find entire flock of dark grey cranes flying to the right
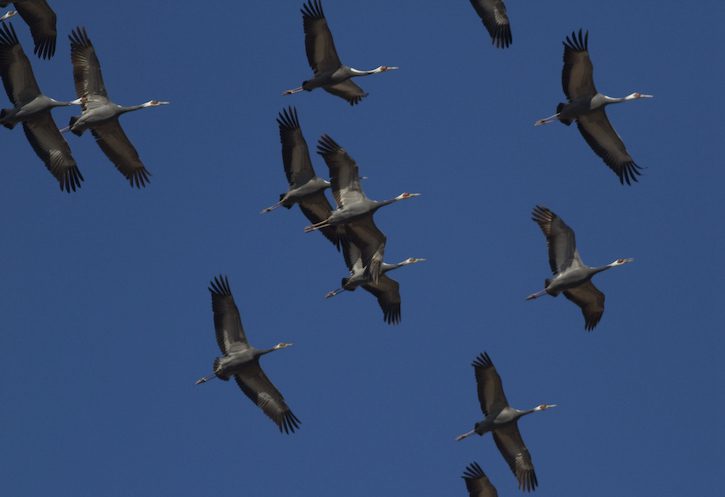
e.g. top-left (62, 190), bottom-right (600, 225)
top-left (0, 0), bottom-right (651, 497)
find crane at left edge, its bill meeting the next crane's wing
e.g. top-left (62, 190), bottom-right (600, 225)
top-left (0, 23), bottom-right (83, 193)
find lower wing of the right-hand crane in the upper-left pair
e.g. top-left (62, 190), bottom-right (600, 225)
top-left (91, 118), bottom-right (151, 188)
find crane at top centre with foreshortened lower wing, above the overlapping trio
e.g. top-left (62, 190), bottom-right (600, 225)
top-left (282, 0), bottom-right (398, 105)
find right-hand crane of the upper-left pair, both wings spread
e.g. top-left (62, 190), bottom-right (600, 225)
top-left (63, 27), bottom-right (169, 188)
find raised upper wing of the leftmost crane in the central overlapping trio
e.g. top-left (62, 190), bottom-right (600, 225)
top-left (277, 107), bottom-right (315, 188)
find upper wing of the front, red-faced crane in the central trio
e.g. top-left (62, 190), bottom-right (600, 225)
top-left (317, 135), bottom-right (366, 207)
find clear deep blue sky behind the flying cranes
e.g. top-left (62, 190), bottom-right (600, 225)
top-left (0, 0), bottom-right (725, 497)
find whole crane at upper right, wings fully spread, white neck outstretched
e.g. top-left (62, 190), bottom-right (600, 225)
top-left (534, 29), bottom-right (653, 185)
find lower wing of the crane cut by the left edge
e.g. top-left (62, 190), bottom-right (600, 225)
top-left (23, 111), bottom-right (83, 193)
